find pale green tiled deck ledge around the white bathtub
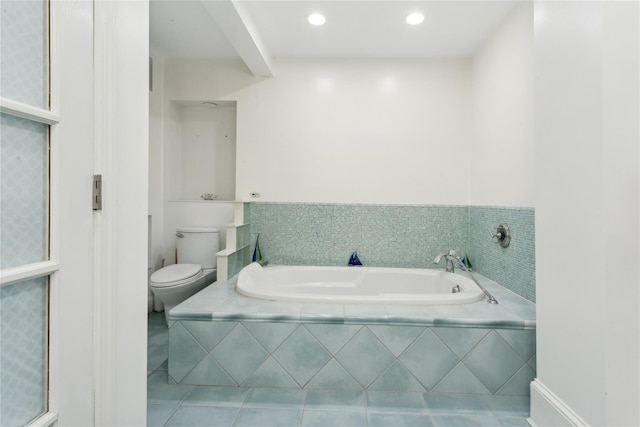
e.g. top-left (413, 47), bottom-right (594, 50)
top-left (169, 272), bottom-right (536, 329)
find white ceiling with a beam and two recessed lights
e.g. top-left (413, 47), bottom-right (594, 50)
top-left (150, 0), bottom-right (517, 75)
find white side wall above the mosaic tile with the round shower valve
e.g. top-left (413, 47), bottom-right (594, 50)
top-left (469, 1), bottom-right (535, 207)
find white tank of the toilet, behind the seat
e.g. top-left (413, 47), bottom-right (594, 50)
top-left (176, 227), bottom-right (220, 269)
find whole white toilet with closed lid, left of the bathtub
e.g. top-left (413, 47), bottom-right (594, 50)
top-left (149, 227), bottom-right (220, 322)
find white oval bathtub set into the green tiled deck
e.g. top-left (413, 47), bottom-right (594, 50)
top-left (237, 263), bottom-right (484, 305)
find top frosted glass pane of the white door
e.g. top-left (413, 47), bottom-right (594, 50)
top-left (0, 0), bottom-right (49, 108)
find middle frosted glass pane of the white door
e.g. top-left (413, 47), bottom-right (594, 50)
top-left (0, 114), bottom-right (49, 269)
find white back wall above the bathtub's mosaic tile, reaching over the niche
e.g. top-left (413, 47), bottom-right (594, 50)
top-left (166, 60), bottom-right (470, 204)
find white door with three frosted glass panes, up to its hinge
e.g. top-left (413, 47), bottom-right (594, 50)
top-left (0, 1), bottom-right (94, 426)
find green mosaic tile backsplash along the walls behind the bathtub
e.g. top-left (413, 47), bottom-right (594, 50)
top-left (245, 203), bottom-right (535, 302)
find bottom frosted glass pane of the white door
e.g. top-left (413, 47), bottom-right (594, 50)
top-left (0, 277), bottom-right (48, 427)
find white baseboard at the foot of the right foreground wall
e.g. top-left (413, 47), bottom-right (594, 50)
top-left (527, 378), bottom-right (588, 427)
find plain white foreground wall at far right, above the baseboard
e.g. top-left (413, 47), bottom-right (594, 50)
top-left (531, 1), bottom-right (640, 426)
